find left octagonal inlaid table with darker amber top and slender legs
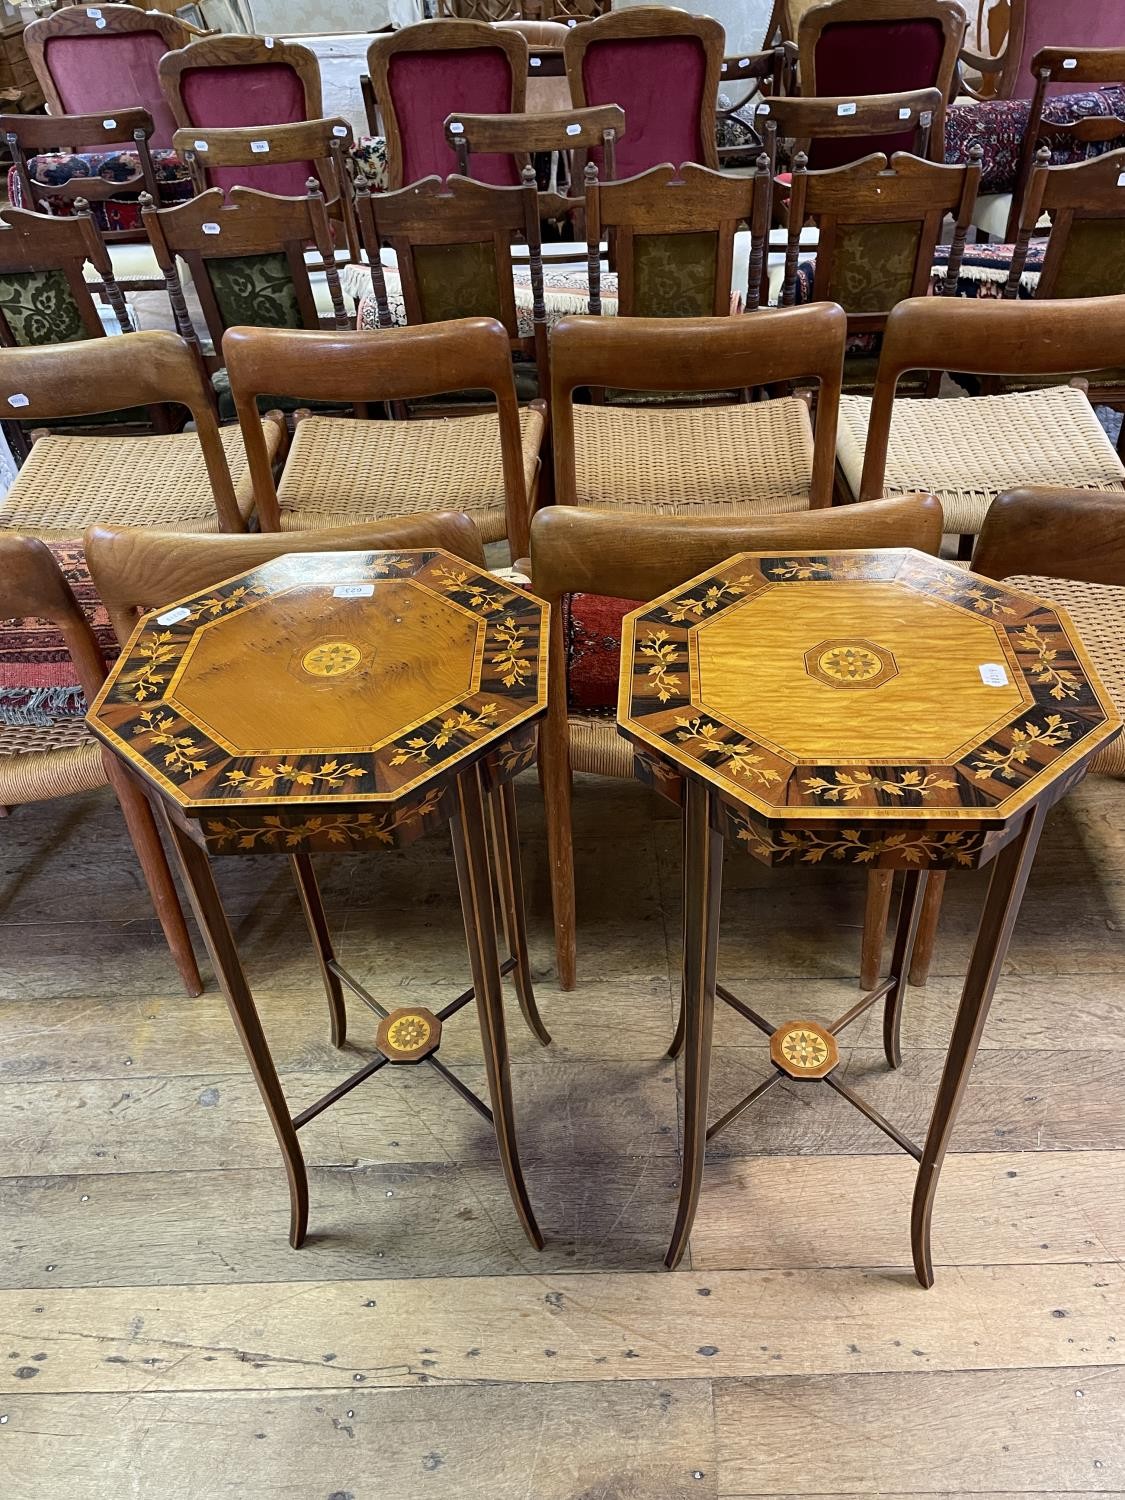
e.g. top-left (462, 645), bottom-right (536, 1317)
top-left (90, 551), bottom-right (551, 1247)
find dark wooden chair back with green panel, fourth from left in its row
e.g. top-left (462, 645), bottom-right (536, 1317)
top-left (585, 156), bottom-right (773, 318)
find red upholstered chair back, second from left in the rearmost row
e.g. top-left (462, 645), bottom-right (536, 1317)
top-left (161, 35), bottom-right (324, 198)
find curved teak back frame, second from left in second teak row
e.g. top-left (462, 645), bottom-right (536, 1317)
top-left (225, 318), bottom-right (543, 557)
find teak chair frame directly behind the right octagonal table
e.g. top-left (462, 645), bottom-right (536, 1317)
top-left (531, 498), bottom-right (942, 990)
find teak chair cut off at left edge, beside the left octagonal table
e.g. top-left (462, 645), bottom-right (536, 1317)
top-left (0, 534), bottom-right (203, 995)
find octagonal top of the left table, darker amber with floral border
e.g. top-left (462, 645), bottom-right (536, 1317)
top-left (89, 551), bottom-right (549, 828)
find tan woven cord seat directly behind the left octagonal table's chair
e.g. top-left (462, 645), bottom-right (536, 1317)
top-left (278, 407), bottom-right (545, 542)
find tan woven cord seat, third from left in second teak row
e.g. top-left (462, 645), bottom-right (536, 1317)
top-left (575, 396), bottom-right (813, 519)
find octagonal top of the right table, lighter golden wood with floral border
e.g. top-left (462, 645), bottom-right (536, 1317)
top-left (618, 549), bottom-right (1121, 846)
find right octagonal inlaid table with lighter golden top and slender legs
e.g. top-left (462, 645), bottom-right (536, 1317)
top-left (618, 551), bottom-right (1121, 1286)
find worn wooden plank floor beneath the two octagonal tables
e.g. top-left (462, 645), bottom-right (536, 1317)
top-left (0, 779), bottom-right (1125, 1500)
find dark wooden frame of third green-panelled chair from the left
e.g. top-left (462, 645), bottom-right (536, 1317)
top-left (356, 167), bottom-right (549, 395)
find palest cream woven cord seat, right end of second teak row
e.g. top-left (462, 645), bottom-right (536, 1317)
top-left (836, 386), bottom-right (1125, 536)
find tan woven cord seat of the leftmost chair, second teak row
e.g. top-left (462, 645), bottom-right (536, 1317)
top-left (0, 422), bottom-right (281, 539)
